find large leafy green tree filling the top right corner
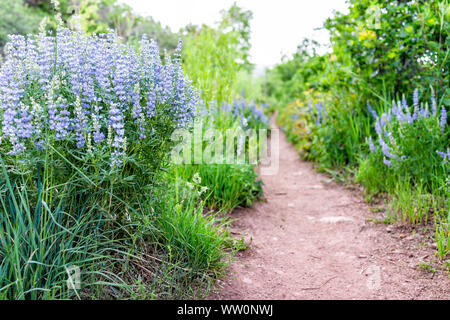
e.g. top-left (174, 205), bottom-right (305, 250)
top-left (325, 0), bottom-right (450, 105)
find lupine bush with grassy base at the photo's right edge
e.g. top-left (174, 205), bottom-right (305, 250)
top-left (356, 91), bottom-right (450, 228)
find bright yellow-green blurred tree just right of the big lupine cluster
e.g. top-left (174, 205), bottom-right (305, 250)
top-left (183, 4), bottom-right (253, 106)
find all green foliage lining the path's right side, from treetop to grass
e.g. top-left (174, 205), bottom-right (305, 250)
top-left (266, 0), bottom-right (450, 256)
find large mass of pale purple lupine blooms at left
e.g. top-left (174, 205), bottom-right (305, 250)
top-left (0, 27), bottom-right (198, 166)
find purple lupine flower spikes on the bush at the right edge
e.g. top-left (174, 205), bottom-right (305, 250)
top-left (367, 89), bottom-right (450, 167)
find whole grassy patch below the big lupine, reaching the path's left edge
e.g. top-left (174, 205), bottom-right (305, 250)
top-left (0, 146), bottom-right (239, 299)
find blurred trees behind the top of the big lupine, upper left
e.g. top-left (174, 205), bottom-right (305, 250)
top-left (0, 0), bottom-right (180, 51)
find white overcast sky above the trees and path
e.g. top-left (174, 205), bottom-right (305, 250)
top-left (121, 0), bottom-right (348, 66)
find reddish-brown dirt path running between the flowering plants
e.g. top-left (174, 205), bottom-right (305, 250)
top-left (208, 122), bottom-right (450, 299)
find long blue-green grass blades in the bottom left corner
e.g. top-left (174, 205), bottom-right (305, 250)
top-left (0, 161), bottom-right (134, 299)
